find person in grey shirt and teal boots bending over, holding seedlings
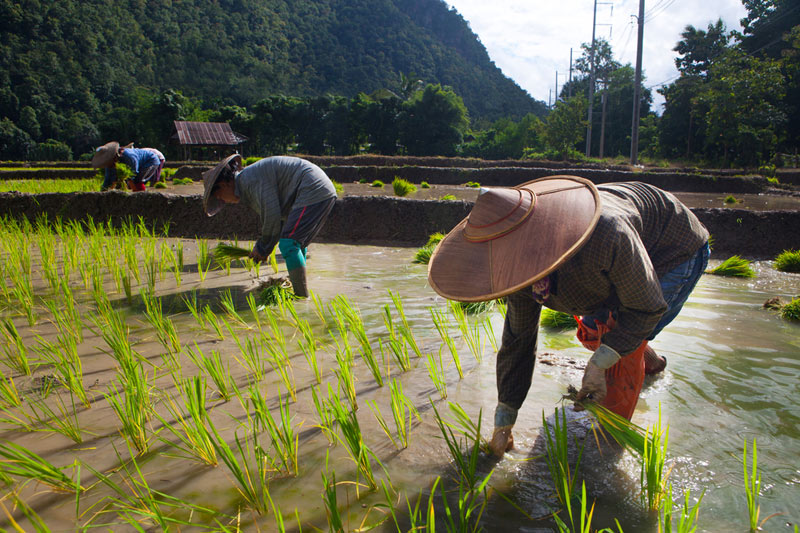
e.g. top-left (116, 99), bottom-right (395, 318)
top-left (203, 154), bottom-right (336, 297)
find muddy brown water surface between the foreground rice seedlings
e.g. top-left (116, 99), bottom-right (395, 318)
top-left (1, 241), bottom-right (800, 531)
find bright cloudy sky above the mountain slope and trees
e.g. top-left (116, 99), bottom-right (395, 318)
top-left (445, 0), bottom-right (746, 113)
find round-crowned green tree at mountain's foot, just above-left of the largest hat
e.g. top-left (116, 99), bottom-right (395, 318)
top-left (400, 84), bottom-right (469, 156)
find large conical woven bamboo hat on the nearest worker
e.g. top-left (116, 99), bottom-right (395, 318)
top-left (428, 176), bottom-right (600, 302)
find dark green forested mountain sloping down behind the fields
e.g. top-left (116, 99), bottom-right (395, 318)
top-left (0, 0), bottom-right (545, 136)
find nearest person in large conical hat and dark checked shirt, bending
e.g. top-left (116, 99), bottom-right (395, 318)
top-left (428, 176), bottom-right (709, 456)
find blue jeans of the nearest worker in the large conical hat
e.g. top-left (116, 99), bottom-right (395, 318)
top-left (581, 243), bottom-right (711, 341)
